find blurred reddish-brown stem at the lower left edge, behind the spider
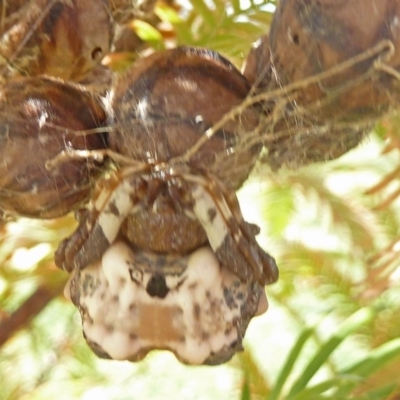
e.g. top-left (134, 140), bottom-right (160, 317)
top-left (0, 285), bottom-right (62, 347)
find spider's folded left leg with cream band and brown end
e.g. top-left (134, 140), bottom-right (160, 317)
top-left (55, 177), bottom-right (145, 271)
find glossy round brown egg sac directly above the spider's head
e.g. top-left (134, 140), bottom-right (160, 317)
top-left (110, 47), bottom-right (260, 189)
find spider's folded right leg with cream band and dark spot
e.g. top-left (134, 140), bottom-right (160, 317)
top-left (183, 174), bottom-right (279, 285)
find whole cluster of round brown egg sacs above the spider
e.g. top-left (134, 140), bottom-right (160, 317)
top-left (0, 0), bottom-right (400, 218)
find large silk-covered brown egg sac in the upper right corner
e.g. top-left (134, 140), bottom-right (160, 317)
top-left (245, 0), bottom-right (400, 168)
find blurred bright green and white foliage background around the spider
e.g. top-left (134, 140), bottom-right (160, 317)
top-left (0, 0), bottom-right (400, 400)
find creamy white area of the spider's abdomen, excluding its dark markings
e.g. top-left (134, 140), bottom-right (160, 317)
top-left (66, 242), bottom-right (263, 364)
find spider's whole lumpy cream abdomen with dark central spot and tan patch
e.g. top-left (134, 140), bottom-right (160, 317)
top-left (66, 242), bottom-right (268, 365)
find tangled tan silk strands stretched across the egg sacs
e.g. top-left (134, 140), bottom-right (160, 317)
top-left (1, 0), bottom-right (399, 366)
